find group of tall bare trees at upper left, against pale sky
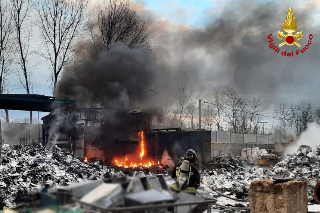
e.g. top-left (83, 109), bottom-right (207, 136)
top-left (0, 0), bottom-right (150, 123)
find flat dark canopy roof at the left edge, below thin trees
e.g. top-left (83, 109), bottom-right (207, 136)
top-left (0, 94), bottom-right (76, 112)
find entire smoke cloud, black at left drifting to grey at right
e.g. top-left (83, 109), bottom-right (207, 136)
top-left (58, 1), bottom-right (320, 118)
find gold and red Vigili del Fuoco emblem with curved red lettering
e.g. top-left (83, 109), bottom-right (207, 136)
top-left (268, 7), bottom-right (313, 57)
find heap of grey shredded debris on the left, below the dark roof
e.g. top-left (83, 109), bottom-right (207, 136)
top-left (0, 144), bottom-right (116, 208)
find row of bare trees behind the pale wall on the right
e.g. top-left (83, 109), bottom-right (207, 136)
top-left (166, 84), bottom-right (320, 135)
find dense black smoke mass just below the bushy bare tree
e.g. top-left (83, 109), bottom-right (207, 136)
top-left (57, 44), bottom-right (159, 109)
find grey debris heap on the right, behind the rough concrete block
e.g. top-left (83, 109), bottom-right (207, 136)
top-left (199, 145), bottom-right (320, 212)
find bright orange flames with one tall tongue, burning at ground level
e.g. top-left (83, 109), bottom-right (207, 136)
top-left (113, 131), bottom-right (155, 168)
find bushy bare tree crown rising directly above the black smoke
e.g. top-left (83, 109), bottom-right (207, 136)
top-left (98, 0), bottom-right (150, 50)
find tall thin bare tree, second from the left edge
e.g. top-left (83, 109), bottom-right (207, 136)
top-left (11, 0), bottom-right (32, 123)
